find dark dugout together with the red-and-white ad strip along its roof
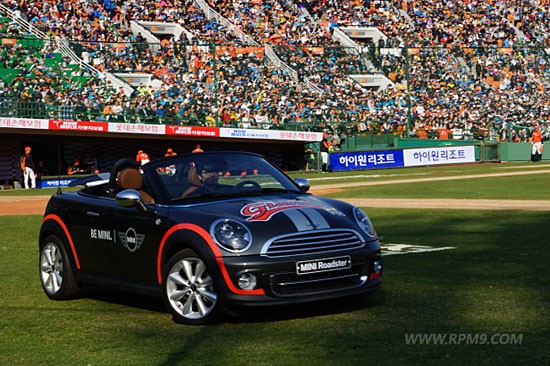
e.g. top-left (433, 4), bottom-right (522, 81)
top-left (0, 118), bottom-right (322, 186)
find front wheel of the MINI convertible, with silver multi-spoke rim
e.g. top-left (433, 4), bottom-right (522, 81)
top-left (162, 249), bottom-right (224, 325)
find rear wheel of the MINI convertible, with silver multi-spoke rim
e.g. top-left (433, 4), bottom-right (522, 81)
top-left (39, 235), bottom-right (80, 300)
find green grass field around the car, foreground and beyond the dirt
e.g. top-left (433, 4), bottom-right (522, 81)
top-left (0, 165), bottom-right (550, 366)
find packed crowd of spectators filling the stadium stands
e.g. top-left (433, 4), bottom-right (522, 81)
top-left (0, 0), bottom-right (550, 140)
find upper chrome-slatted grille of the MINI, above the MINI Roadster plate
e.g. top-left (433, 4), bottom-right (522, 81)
top-left (261, 230), bottom-right (364, 258)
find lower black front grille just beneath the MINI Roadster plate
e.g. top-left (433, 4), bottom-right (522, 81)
top-left (270, 265), bottom-right (367, 297)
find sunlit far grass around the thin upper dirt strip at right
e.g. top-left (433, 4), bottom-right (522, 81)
top-left (290, 163), bottom-right (550, 200)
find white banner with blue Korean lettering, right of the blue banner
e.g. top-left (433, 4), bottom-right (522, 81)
top-left (403, 145), bottom-right (476, 166)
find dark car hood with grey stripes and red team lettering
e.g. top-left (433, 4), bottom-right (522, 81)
top-left (172, 194), bottom-right (367, 250)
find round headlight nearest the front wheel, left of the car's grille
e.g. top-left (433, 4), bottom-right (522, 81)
top-left (210, 219), bottom-right (252, 253)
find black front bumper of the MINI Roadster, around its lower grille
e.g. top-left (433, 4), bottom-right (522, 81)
top-left (218, 249), bottom-right (382, 306)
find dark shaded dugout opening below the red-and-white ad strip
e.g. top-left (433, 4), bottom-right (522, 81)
top-left (0, 129), bottom-right (312, 186)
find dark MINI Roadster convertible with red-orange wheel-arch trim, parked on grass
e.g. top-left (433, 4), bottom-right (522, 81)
top-left (39, 151), bottom-right (382, 325)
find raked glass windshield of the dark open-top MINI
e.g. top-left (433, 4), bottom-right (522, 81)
top-left (144, 152), bottom-right (301, 202)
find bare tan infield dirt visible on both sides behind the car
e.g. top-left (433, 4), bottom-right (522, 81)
top-left (0, 169), bottom-right (550, 216)
